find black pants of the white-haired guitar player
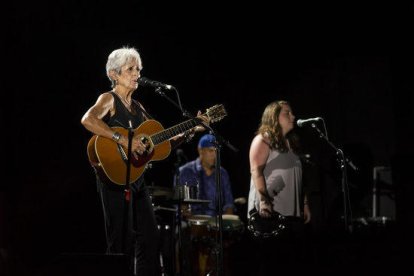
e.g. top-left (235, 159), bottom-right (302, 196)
top-left (98, 180), bottom-right (160, 276)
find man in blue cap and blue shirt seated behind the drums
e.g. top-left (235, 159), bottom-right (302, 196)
top-left (175, 134), bottom-right (234, 217)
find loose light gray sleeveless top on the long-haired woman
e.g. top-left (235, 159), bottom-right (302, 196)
top-left (247, 150), bottom-right (302, 217)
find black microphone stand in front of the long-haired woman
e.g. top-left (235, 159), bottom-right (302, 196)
top-left (311, 123), bottom-right (355, 233)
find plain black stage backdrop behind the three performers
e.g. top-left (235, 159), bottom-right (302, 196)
top-left (0, 0), bottom-right (414, 275)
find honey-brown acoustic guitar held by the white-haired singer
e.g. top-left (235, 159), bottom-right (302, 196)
top-left (87, 105), bottom-right (227, 185)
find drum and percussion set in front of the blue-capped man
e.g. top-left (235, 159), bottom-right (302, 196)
top-left (149, 185), bottom-right (245, 275)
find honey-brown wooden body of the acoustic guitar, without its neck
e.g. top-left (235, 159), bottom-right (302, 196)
top-left (88, 120), bottom-right (171, 185)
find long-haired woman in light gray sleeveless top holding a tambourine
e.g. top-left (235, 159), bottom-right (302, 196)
top-left (248, 101), bottom-right (311, 275)
